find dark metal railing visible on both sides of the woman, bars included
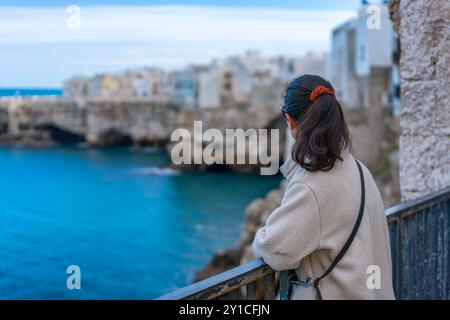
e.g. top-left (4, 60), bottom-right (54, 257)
top-left (158, 187), bottom-right (450, 300)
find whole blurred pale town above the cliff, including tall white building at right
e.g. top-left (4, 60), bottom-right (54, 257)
top-left (63, 4), bottom-right (400, 115)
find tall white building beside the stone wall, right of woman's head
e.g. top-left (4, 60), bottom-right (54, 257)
top-left (330, 4), bottom-right (395, 108)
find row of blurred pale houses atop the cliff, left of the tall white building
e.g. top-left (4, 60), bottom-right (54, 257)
top-left (64, 51), bottom-right (327, 110)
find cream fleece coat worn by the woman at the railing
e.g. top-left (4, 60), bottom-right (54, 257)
top-left (253, 152), bottom-right (394, 300)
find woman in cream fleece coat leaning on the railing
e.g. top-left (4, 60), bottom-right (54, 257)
top-left (253, 75), bottom-right (394, 299)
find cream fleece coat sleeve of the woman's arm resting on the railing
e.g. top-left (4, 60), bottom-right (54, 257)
top-left (252, 183), bottom-right (320, 271)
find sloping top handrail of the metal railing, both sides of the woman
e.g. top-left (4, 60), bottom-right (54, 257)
top-left (157, 186), bottom-right (450, 300)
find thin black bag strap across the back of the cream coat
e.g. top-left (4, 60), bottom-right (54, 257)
top-left (313, 159), bottom-right (366, 300)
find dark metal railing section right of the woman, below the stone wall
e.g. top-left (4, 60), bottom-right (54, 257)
top-left (386, 187), bottom-right (450, 300)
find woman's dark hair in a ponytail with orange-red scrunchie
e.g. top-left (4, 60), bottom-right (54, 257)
top-left (283, 75), bottom-right (351, 172)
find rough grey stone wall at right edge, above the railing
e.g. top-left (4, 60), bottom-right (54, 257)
top-left (390, 0), bottom-right (450, 200)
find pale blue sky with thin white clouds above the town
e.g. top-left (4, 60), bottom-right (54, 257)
top-left (0, 0), bottom-right (360, 88)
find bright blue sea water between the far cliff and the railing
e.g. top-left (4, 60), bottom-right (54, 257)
top-left (0, 148), bottom-right (280, 299)
